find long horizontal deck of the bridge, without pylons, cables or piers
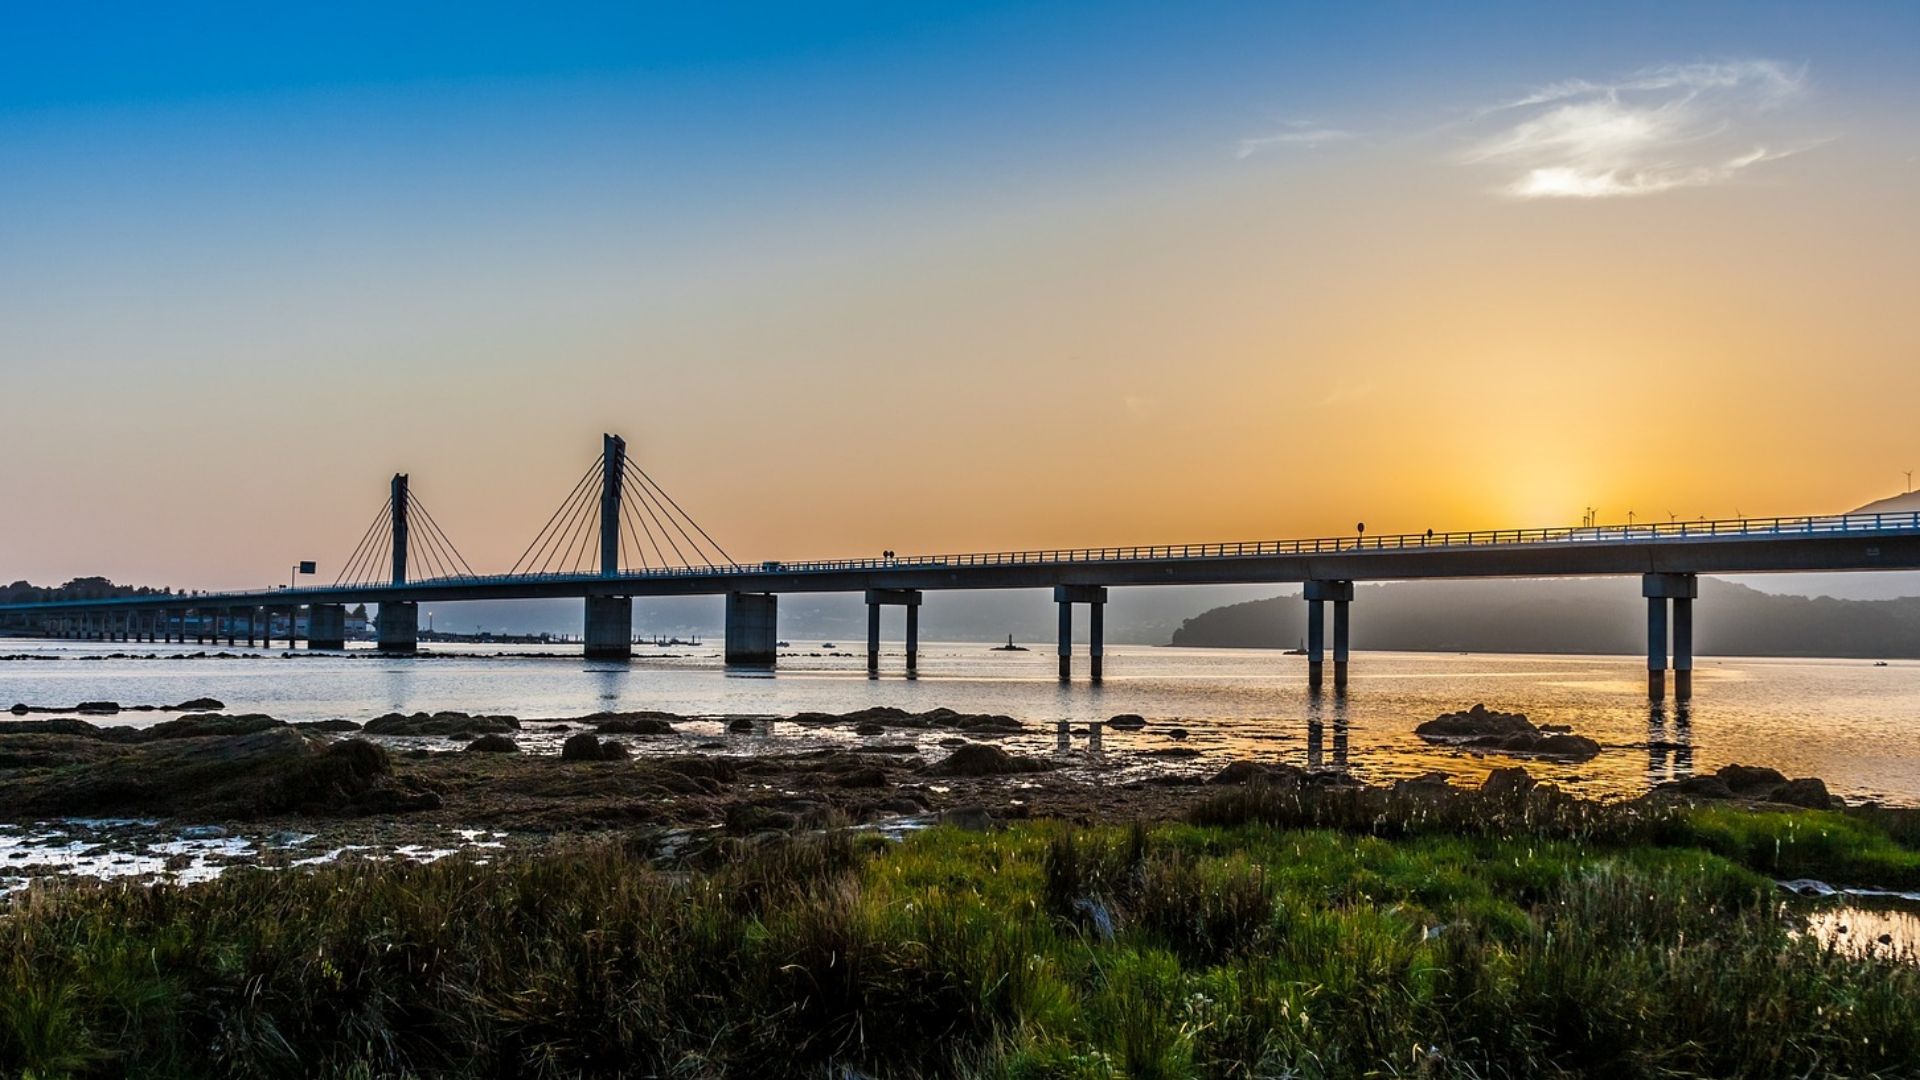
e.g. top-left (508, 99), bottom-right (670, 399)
top-left (0, 513), bottom-right (1920, 613)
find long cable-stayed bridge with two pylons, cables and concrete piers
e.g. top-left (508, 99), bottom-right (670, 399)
top-left (0, 434), bottom-right (1920, 701)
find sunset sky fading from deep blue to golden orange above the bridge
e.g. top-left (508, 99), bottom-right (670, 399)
top-left (0, 2), bottom-right (1920, 588)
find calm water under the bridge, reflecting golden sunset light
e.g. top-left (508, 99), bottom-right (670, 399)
top-left (0, 640), bottom-right (1920, 805)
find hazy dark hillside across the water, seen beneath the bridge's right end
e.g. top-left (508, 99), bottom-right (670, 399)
top-left (1171, 577), bottom-right (1920, 659)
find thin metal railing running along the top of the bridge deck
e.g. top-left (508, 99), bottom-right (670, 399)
top-left (15, 511), bottom-right (1920, 605)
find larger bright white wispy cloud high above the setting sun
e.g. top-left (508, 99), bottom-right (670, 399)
top-left (1463, 60), bottom-right (1814, 198)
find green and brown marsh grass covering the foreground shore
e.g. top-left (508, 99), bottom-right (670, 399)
top-left (0, 796), bottom-right (1920, 1080)
